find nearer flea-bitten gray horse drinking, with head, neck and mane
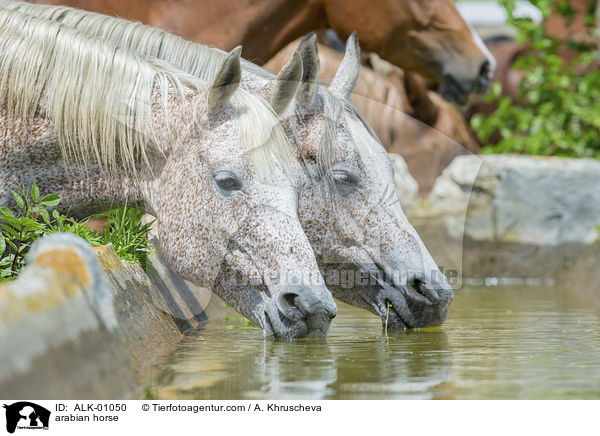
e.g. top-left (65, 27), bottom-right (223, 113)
top-left (0, 9), bottom-right (336, 338)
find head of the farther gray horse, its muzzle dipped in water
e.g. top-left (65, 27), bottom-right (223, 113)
top-left (284, 34), bottom-right (453, 328)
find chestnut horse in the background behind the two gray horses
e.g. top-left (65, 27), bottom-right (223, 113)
top-left (29, 0), bottom-right (496, 104)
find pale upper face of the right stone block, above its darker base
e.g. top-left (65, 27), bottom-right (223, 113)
top-left (429, 155), bottom-right (600, 247)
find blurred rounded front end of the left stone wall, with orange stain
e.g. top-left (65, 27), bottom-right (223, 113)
top-left (0, 234), bottom-right (136, 399)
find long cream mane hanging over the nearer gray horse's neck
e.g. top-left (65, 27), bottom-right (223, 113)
top-left (0, 6), bottom-right (202, 173)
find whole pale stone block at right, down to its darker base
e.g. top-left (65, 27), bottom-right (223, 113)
top-left (410, 155), bottom-right (600, 278)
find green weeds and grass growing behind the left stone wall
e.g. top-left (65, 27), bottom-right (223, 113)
top-left (0, 183), bottom-right (152, 280)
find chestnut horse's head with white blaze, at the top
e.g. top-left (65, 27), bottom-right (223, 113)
top-left (326, 0), bottom-right (496, 104)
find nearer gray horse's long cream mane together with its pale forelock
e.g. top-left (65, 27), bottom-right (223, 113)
top-left (0, 5), bottom-right (294, 173)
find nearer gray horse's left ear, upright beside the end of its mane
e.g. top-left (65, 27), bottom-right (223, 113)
top-left (208, 46), bottom-right (242, 114)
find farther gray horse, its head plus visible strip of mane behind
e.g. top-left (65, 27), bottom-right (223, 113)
top-left (3, 0), bottom-right (453, 328)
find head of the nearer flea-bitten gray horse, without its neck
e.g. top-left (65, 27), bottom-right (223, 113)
top-left (152, 49), bottom-right (336, 338)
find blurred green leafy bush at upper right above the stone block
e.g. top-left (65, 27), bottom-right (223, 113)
top-left (471, 0), bottom-right (600, 158)
